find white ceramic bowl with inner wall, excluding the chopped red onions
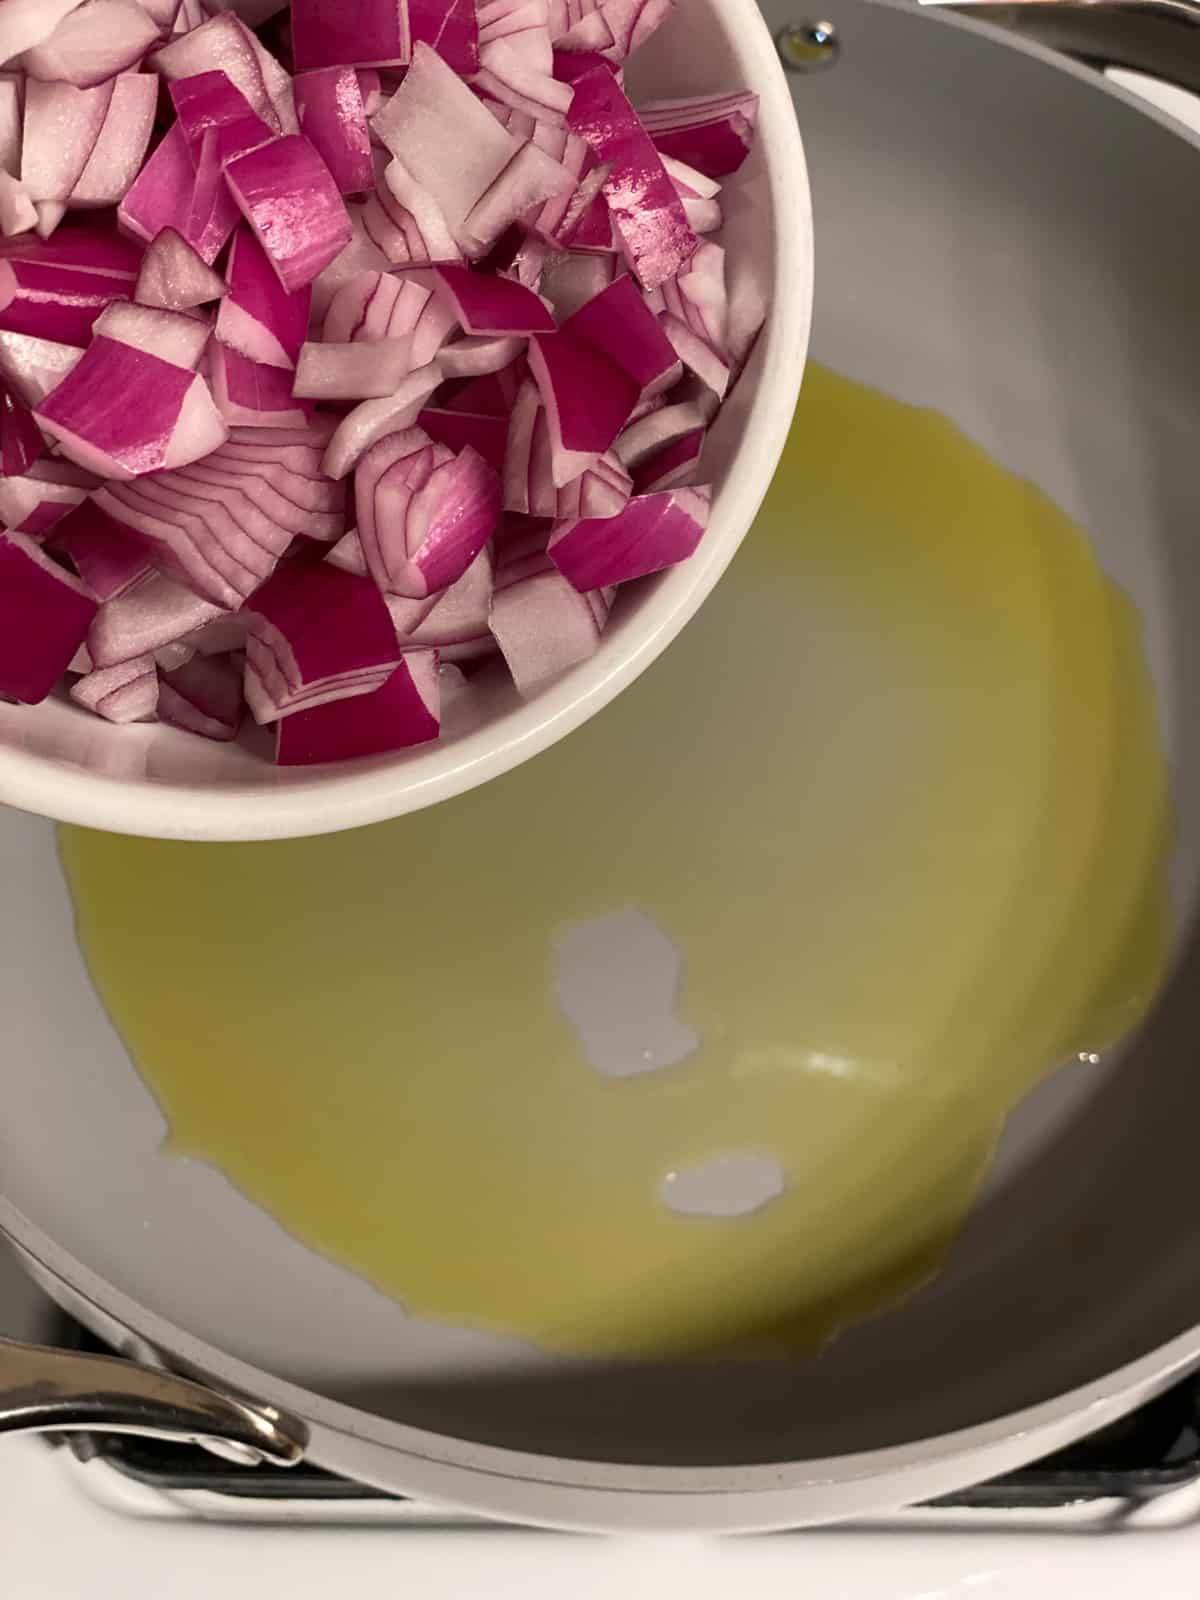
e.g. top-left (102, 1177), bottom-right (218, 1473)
top-left (0, 0), bottom-right (813, 838)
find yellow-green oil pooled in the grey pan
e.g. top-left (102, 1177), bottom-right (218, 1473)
top-left (61, 370), bottom-right (1171, 1355)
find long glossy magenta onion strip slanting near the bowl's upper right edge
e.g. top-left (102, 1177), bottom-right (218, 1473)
top-left (568, 67), bottom-right (698, 288)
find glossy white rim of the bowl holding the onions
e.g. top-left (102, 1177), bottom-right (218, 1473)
top-left (0, 0), bottom-right (813, 840)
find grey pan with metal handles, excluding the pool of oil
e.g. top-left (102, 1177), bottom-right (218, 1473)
top-left (0, 0), bottom-right (1200, 1531)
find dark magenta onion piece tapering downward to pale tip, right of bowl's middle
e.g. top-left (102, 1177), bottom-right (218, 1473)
top-left (528, 320), bottom-right (640, 488)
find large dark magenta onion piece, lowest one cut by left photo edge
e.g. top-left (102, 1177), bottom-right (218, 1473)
top-left (0, 533), bottom-right (96, 706)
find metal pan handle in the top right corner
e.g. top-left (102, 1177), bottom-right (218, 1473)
top-left (920, 0), bottom-right (1200, 94)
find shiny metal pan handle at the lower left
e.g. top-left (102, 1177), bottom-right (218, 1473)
top-left (0, 1339), bottom-right (307, 1467)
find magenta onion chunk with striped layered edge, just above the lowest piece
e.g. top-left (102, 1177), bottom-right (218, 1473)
top-left (246, 560), bottom-right (400, 722)
